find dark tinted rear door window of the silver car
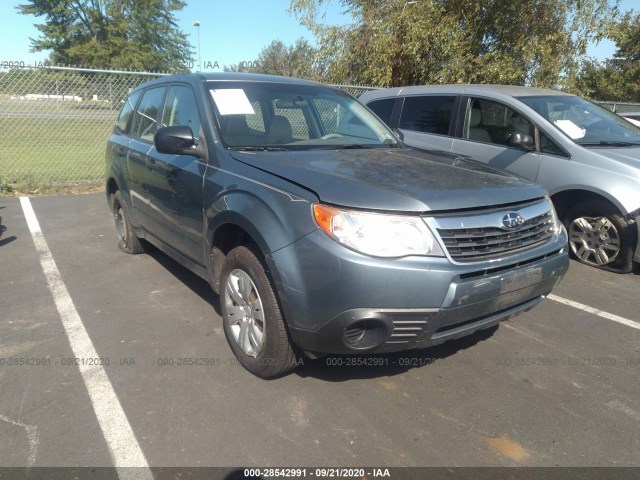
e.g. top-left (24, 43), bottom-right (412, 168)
top-left (399, 95), bottom-right (455, 135)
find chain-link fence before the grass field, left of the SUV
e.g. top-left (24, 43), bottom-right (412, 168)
top-left (0, 67), bottom-right (168, 190)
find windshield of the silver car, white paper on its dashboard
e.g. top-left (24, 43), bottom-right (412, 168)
top-left (519, 95), bottom-right (640, 147)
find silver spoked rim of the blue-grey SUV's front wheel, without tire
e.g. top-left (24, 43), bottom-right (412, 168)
top-left (224, 269), bottom-right (265, 357)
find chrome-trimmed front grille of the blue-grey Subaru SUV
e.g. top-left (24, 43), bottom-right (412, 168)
top-left (438, 211), bottom-right (553, 261)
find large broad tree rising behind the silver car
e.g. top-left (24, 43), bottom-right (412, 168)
top-left (289, 0), bottom-right (617, 90)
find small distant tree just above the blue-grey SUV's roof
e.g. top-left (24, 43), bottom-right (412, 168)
top-left (225, 37), bottom-right (323, 80)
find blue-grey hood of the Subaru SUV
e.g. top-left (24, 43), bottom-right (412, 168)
top-left (231, 149), bottom-right (546, 212)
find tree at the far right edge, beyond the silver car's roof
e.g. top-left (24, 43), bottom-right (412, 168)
top-left (578, 12), bottom-right (640, 102)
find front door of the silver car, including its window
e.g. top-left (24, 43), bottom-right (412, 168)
top-left (451, 97), bottom-right (541, 181)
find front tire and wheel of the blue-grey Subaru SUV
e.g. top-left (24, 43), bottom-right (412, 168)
top-left (220, 247), bottom-right (297, 378)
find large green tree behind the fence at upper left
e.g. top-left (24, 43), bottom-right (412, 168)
top-left (16, 0), bottom-right (192, 71)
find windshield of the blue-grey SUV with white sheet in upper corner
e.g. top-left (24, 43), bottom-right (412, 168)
top-left (207, 82), bottom-right (399, 151)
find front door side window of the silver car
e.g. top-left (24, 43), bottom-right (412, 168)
top-left (463, 98), bottom-right (535, 150)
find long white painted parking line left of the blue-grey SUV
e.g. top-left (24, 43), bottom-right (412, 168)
top-left (20, 197), bottom-right (153, 480)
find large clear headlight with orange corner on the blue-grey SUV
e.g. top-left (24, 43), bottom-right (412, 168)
top-left (313, 204), bottom-right (444, 257)
